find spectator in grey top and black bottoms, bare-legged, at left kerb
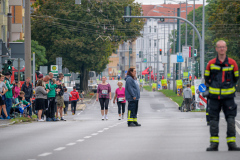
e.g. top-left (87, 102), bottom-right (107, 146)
top-left (35, 80), bottom-right (49, 122)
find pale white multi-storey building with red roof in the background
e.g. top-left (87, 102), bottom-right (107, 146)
top-left (136, 4), bottom-right (202, 76)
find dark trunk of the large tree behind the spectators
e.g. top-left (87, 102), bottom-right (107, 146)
top-left (80, 65), bottom-right (89, 92)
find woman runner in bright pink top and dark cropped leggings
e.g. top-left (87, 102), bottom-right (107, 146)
top-left (113, 81), bottom-right (126, 120)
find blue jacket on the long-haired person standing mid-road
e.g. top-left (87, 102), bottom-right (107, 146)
top-left (125, 75), bottom-right (140, 101)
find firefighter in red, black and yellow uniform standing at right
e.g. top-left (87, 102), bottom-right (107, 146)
top-left (205, 40), bottom-right (240, 151)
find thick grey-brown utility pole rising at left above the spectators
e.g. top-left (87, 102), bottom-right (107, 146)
top-left (24, 0), bottom-right (31, 79)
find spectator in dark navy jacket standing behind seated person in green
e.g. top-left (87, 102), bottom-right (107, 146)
top-left (21, 77), bottom-right (33, 117)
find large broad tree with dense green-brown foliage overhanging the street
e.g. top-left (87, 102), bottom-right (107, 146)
top-left (32, 0), bottom-right (144, 90)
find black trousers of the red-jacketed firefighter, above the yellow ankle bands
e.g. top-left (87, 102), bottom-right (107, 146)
top-left (208, 98), bottom-right (237, 138)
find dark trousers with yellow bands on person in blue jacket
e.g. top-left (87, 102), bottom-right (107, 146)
top-left (128, 100), bottom-right (138, 124)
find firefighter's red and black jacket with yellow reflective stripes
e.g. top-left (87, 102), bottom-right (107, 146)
top-left (204, 57), bottom-right (239, 99)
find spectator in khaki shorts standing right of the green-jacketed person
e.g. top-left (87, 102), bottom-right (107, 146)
top-left (56, 73), bottom-right (66, 121)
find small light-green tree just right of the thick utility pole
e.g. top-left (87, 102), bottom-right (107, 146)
top-left (16, 40), bottom-right (48, 70)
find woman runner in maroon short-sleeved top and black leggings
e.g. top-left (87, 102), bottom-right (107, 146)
top-left (96, 76), bottom-right (112, 121)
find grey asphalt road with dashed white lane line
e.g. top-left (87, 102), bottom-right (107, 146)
top-left (0, 81), bottom-right (240, 160)
